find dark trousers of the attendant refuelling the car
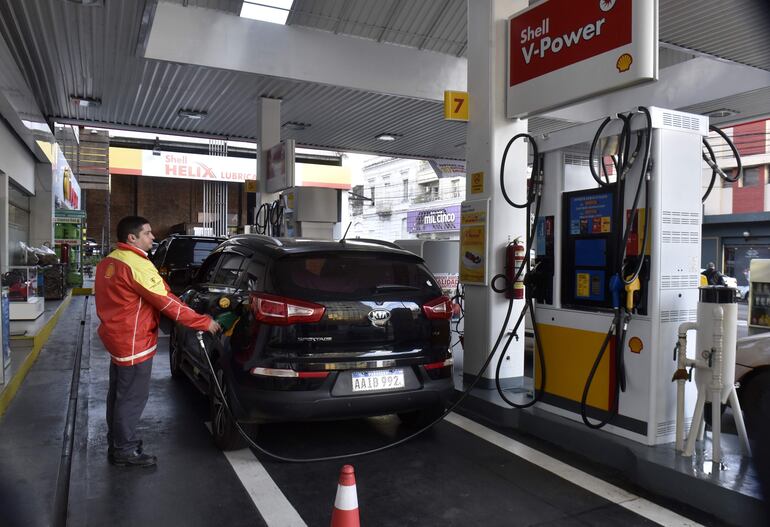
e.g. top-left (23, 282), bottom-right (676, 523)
top-left (107, 359), bottom-right (152, 455)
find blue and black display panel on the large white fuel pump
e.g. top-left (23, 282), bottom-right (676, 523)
top-left (562, 187), bottom-right (615, 309)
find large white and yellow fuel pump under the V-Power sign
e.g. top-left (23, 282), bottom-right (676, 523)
top-left (535, 107), bottom-right (708, 445)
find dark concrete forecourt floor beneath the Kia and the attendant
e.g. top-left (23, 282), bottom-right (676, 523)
top-left (0, 297), bottom-right (752, 527)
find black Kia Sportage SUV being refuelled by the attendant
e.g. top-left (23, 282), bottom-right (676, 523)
top-left (169, 235), bottom-right (453, 449)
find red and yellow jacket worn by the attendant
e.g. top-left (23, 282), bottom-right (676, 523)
top-left (94, 243), bottom-right (211, 366)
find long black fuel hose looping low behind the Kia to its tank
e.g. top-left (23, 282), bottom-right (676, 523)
top-left (196, 290), bottom-right (513, 463)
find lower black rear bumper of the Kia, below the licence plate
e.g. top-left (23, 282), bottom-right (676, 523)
top-left (231, 375), bottom-right (454, 422)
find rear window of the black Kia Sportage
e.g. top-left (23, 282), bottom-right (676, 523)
top-left (273, 253), bottom-right (441, 300)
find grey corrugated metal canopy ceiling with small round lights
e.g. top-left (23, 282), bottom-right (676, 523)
top-left (0, 0), bottom-right (770, 158)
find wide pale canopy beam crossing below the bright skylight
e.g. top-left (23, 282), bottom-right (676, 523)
top-left (145, 2), bottom-right (468, 101)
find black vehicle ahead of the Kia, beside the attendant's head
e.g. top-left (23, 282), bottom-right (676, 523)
top-left (150, 234), bottom-right (226, 295)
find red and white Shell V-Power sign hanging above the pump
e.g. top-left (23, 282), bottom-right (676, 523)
top-left (506, 0), bottom-right (658, 119)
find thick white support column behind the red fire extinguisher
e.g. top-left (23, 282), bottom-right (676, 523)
top-left (463, 0), bottom-right (528, 388)
